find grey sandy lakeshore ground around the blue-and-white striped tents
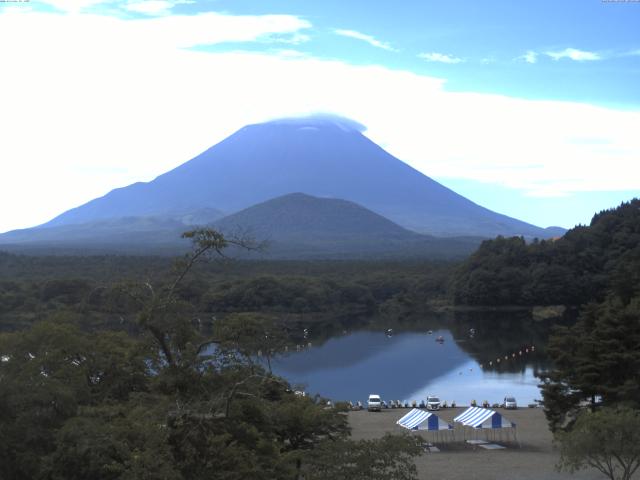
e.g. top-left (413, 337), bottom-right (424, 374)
top-left (349, 408), bottom-right (616, 480)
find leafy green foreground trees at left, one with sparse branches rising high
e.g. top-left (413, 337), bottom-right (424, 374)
top-left (0, 230), bottom-right (422, 480)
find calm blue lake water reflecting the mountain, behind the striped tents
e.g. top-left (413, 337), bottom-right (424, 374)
top-left (273, 330), bottom-right (541, 406)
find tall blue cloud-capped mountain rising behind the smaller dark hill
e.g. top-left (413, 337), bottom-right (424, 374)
top-left (44, 117), bottom-right (550, 238)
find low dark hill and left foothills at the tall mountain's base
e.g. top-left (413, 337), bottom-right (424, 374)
top-left (0, 193), bottom-right (481, 259)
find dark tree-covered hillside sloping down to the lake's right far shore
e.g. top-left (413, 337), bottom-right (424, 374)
top-left (453, 199), bottom-right (640, 305)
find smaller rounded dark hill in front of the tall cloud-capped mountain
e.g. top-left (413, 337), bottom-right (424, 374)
top-left (214, 193), bottom-right (481, 258)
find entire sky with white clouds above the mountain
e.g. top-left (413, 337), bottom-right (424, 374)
top-left (0, 0), bottom-right (640, 231)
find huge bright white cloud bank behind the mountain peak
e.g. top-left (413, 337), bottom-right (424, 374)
top-left (0, 8), bottom-right (640, 231)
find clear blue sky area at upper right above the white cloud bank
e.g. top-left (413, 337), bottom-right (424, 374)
top-left (172, 0), bottom-right (640, 109)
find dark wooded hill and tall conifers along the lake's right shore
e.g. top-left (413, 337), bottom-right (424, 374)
top-left (452, 199), bottom-right (640, 438)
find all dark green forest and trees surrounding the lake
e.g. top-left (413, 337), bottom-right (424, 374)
top-left (0, 200), bottom-right (640, 480)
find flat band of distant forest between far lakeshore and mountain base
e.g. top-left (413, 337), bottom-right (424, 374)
top-left (0, 253), bottom-right (451, 330)
